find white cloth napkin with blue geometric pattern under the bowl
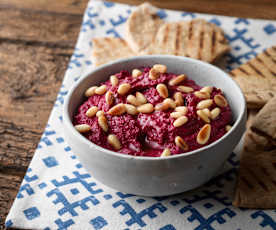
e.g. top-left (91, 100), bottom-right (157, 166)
top-left (6, 0), bottom-right (276, 230)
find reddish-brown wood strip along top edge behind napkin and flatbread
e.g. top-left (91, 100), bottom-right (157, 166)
top-left (113, 0), bottom-right (276, 20)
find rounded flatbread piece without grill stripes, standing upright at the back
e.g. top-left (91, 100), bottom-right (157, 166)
top-left (125, 2), bottom-right (164, 52)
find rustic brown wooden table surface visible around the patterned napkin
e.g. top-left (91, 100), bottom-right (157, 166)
top-left (0, 0), bottom-right (276, 229)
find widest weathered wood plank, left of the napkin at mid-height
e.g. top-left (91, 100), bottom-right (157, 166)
top-left (0, 43), bottom-right (72, 172)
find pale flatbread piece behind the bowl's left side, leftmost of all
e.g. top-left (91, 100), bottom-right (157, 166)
top-left (92, 37), bottom-right (137, 66)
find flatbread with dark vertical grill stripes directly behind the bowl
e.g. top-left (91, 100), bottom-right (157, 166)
top-left (142, 19), bottom-right (230, 62)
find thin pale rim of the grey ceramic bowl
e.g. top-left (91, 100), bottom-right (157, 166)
top-left (63, 55), bottom-right (246, 161)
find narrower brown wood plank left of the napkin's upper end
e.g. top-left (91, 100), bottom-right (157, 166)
top-left (0, 6), bottom-right (82, 48)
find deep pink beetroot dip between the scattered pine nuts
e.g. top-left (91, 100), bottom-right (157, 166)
top-left (73, 67), bottom-right (232, 157)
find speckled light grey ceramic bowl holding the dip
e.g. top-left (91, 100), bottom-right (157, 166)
top-left (63, 55), bottom-right (246, 196)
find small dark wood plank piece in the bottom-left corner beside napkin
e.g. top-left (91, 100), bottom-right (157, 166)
top-left (0, 170), bottom-right (22, 230)
